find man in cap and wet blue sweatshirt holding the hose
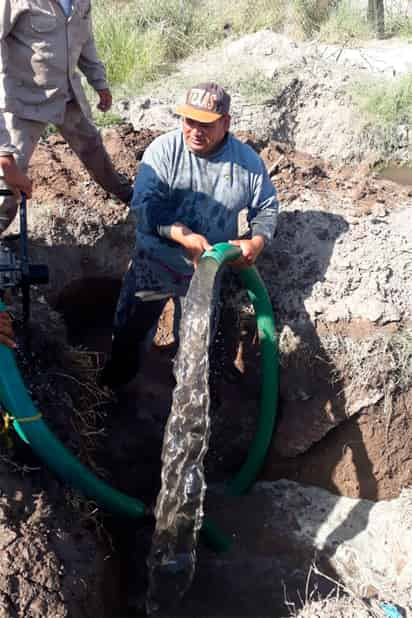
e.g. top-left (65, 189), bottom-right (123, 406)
top-left (100, 83), bottom-right (278, 388)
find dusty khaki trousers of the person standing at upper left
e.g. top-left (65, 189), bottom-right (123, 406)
top-left (0, 101), bottom-right (132, 234)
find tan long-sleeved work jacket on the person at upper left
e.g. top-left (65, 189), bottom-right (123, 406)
top-left (0, 0), bottom-right (108, 153)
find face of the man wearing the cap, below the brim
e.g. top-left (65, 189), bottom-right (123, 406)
top-left (183, 114), bottom-right (230, 156)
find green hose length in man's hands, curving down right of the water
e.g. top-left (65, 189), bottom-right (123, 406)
top-left (202, 243), bottom-right (279, 495)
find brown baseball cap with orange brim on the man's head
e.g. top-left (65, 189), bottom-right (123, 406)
top-left (176, 82), bottom-right (230, 122)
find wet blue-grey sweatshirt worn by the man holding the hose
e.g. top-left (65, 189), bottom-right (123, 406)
top-left (132, 129), bottom-right (278, 292)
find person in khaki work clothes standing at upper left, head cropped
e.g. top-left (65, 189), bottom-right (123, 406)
top-left (0, 0), bottom-right (132, 234)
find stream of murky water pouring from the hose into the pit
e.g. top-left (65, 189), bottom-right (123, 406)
top-left (147, 261), bottom-right (220, 614)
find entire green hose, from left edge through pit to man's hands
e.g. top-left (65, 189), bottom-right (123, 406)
top-left (0, 243), bottom-right (278, 552)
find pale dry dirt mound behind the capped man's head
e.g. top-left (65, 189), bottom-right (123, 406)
top-left (119, 30), bottom-right (411, 163)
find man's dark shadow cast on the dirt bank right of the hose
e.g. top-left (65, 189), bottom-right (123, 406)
top-left (235, 210), bottom-right (377, 594)
